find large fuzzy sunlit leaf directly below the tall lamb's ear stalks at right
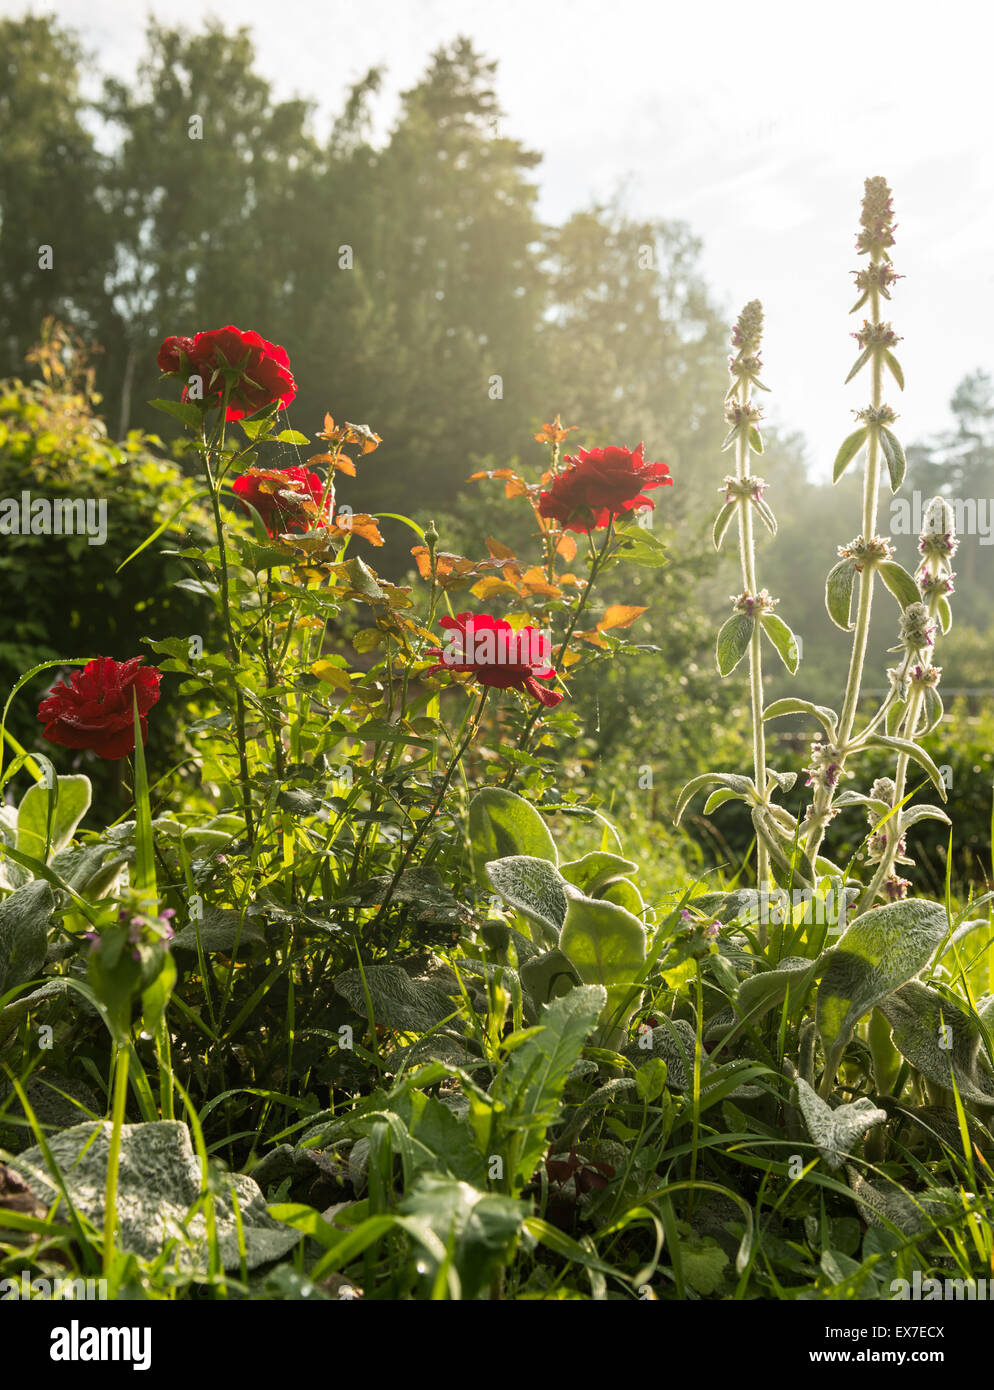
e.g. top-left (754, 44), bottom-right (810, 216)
top-left (816, 898), bottom-right (948, 1069)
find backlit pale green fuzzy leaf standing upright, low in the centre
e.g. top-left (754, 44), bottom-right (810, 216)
top-left (559, 898), bottom-right (645, 1047)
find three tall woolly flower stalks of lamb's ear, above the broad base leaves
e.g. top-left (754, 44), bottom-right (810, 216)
top-left (676, 178), bottom-right (955, 911)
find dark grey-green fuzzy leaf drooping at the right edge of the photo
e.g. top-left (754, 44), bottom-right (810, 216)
top-left (879, 980), bottom-right (994, 1109)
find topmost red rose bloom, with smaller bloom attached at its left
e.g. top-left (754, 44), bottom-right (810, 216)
top-left (157, 324), bottom-right (296, 420)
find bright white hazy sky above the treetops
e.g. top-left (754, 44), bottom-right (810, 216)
top-left (13, 0), bottom-right (994, 475)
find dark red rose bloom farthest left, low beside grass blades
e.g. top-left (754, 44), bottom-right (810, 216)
top-left (38, 656), bottom-right (161, 759)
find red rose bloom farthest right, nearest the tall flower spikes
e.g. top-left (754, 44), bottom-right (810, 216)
top-left (538, 443), bottom-right (673, 532)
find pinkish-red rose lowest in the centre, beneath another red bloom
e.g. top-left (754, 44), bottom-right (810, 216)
top-left (424, 613), bottom-right (563, 709)
